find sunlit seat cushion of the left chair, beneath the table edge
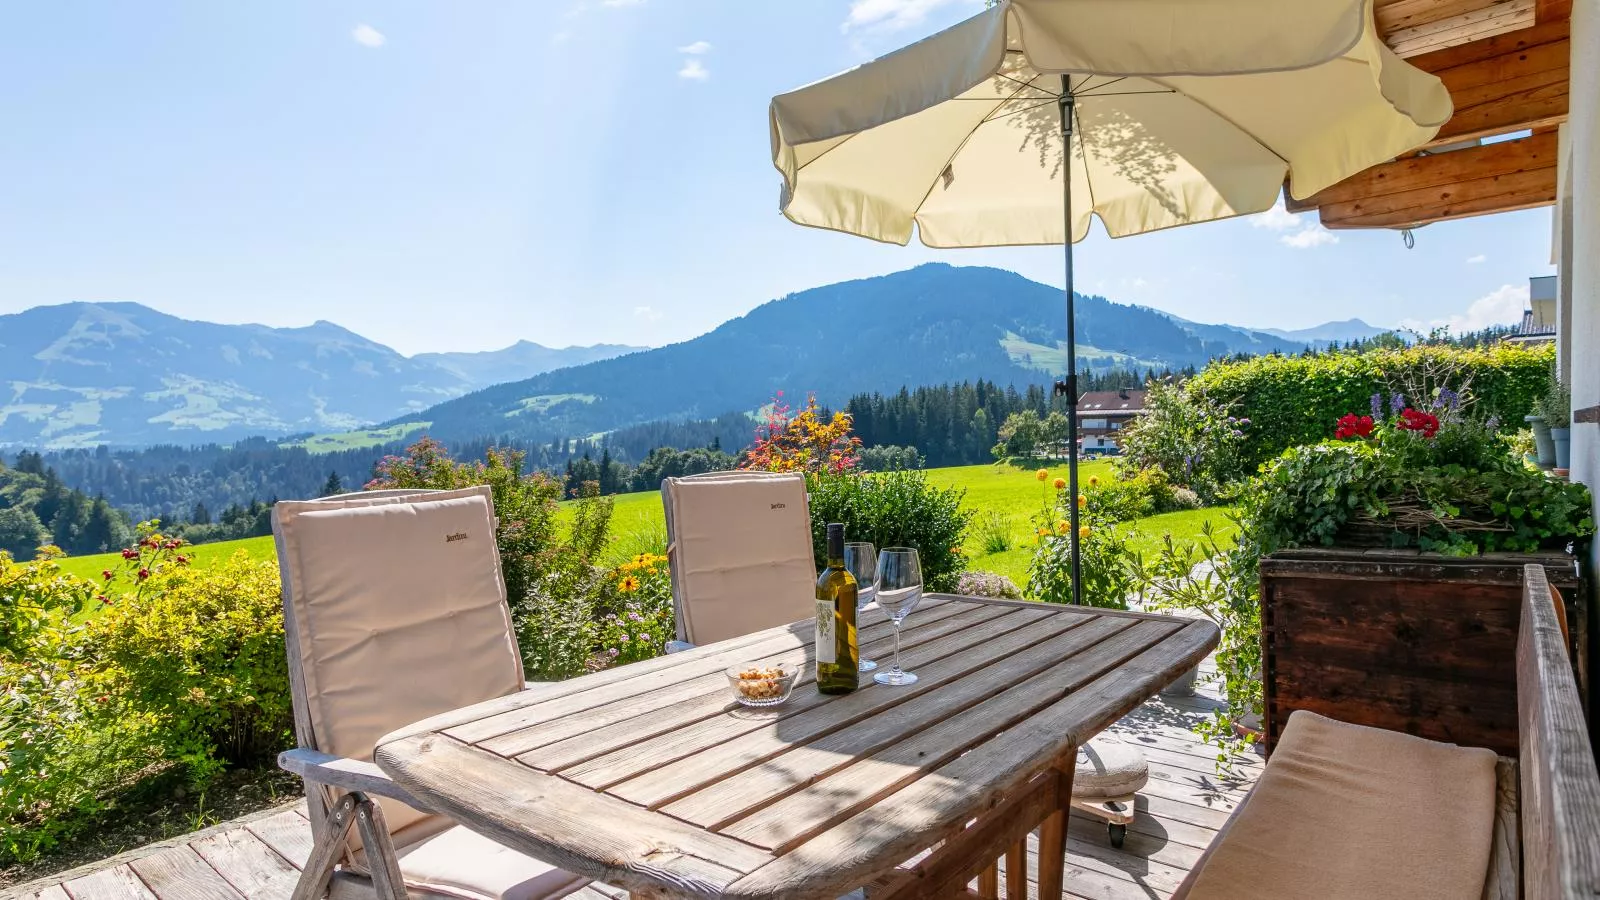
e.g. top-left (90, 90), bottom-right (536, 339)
top-left (398, 825), bottom-right (589, 900)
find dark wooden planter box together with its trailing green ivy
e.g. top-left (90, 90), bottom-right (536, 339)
top-left (1235, 389), bottom-right (1594, 753)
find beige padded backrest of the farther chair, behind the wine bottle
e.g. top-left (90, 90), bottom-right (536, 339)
top-left (661, 472), bottom-right (816, 644)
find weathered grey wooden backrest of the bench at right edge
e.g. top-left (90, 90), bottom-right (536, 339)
top-left (1517, 565), bottom-right (1600, 900)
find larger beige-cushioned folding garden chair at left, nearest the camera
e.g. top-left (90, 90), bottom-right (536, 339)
top-left (272, 487), bottom-right (587, 900)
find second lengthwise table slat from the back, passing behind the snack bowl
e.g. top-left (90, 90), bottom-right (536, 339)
top-left (472, 604), bottom-right (976, 755)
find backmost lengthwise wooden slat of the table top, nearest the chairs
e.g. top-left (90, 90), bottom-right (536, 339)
top-left (432, 601), bottom-right (949, 743)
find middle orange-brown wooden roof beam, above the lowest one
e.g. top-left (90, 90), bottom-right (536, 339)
top-left (1411, 21), bottom-right (1571, 147)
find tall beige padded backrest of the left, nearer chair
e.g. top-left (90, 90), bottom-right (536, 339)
top-left (272, 487), bottom-right (523, 850)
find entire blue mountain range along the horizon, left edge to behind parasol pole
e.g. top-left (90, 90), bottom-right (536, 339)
top-left (0, 264), bottom-right (1371, 448)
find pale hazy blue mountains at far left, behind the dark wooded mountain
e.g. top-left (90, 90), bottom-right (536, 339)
top-left (0, 303), bottom-right (637, 447)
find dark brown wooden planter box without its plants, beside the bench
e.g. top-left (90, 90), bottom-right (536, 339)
top-left (1261, 549), bottom-right (1589, 756)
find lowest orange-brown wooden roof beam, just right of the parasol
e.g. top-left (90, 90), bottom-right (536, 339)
top-left (1315, 133), bottom-right (1557, 229)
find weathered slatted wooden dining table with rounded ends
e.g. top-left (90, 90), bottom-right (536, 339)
top-left (376, 594), bottom-right (1218, 900)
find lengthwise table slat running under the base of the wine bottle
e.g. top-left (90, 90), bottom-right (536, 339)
top-left (562, 610), bottom-right (1068, 790)
